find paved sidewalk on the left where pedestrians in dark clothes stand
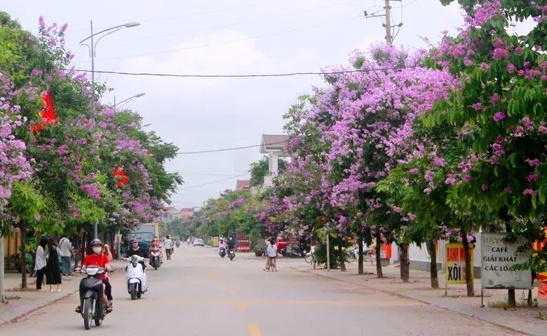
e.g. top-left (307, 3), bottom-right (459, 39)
top-left (0, 260), bottom-right (125, 328)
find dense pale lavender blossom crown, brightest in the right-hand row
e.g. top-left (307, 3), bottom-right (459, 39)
top-left (308, 45), bottom-right (455, 231)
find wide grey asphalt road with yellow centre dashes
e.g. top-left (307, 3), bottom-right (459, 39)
top-left (0, 245), bottom-right (518, 336)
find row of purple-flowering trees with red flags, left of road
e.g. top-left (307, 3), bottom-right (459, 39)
top-left (0, 12), bottom-right (182, 287)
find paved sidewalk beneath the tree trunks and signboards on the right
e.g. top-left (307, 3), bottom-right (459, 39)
top-left (291, 260), bottom-right (547, 336)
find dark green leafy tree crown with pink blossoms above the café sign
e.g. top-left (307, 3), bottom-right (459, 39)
top-left (432, 0), bottom-right (547, 216)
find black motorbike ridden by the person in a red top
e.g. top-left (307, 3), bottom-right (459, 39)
top-left (80, 265), bottom-right (108, 330)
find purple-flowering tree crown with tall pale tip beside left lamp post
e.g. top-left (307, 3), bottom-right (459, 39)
top-left (30, 17), bottom-right (167, 227)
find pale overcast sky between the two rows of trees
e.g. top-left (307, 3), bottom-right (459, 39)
top-left (0, 0), bottom-right (524, 209)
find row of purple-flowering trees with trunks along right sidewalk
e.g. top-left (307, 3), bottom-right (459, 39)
top-left (189, 0), bottom-right (547, 305)
